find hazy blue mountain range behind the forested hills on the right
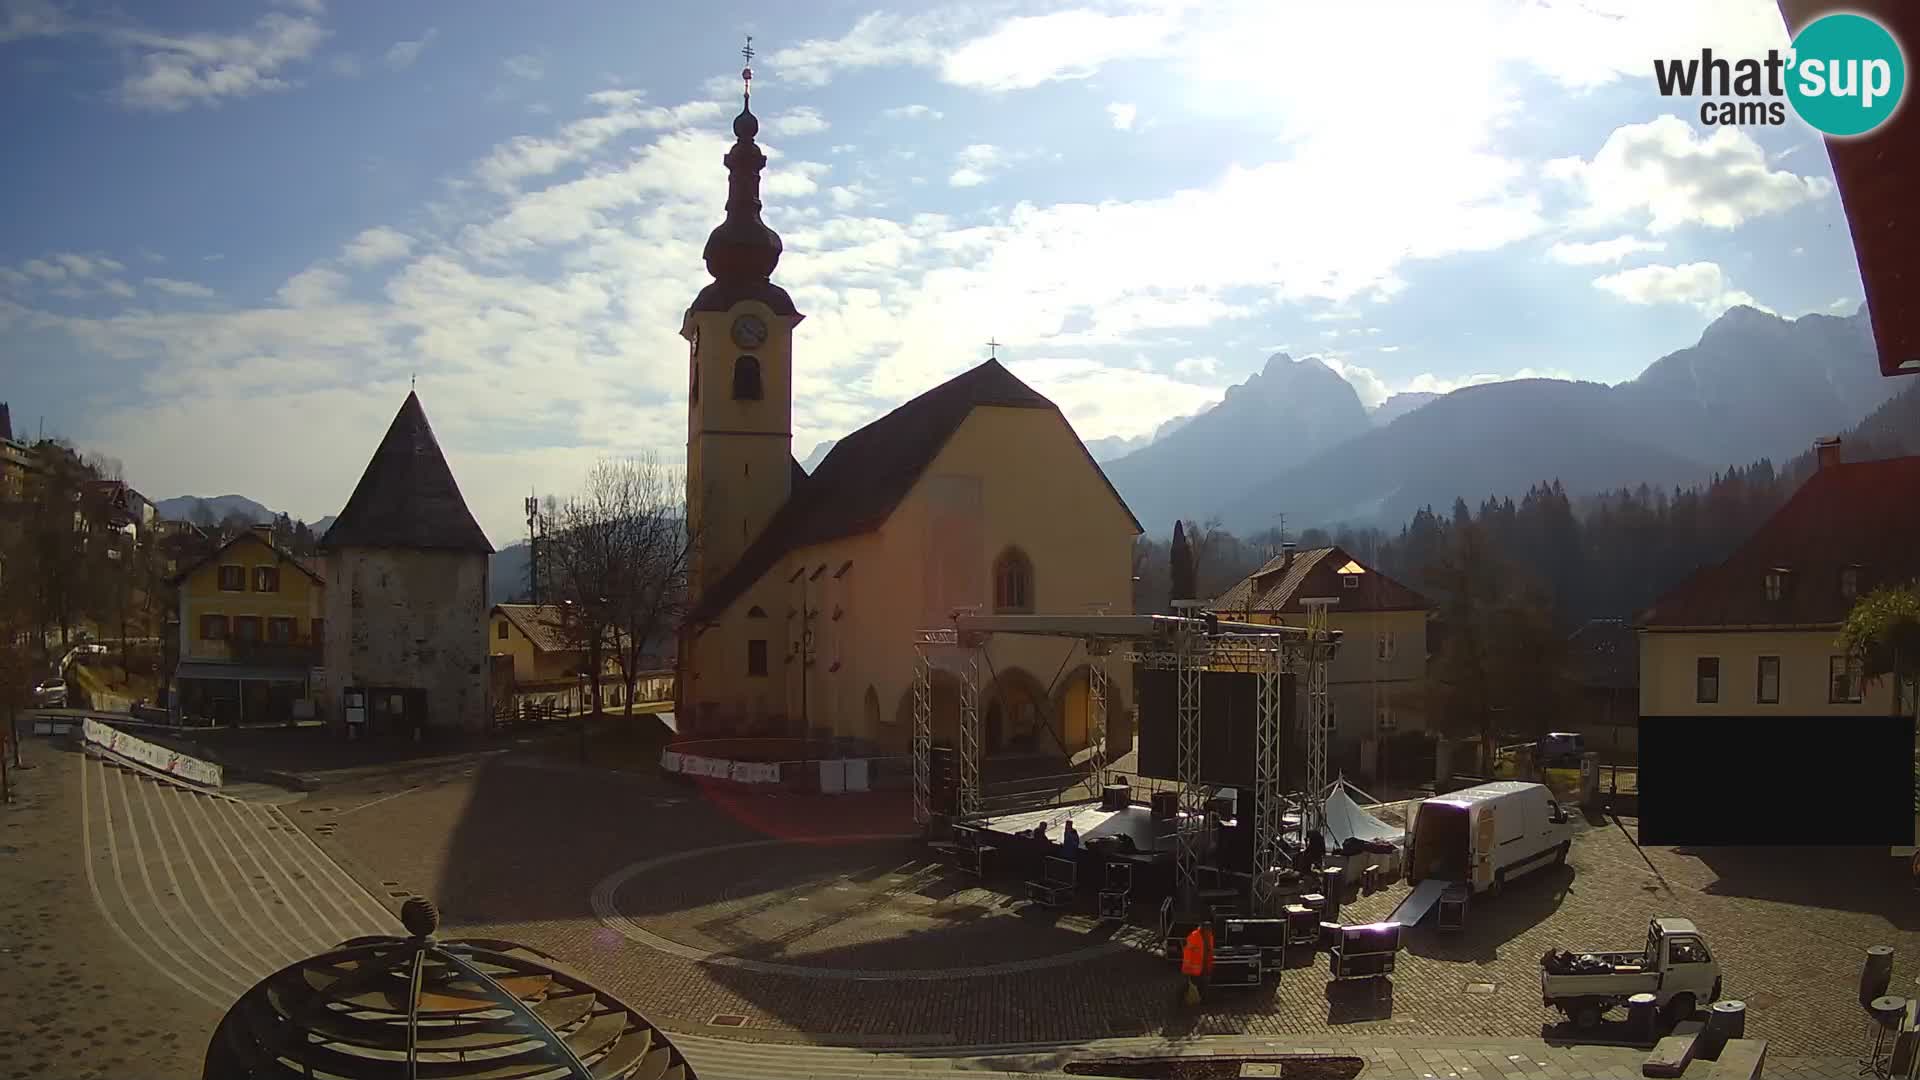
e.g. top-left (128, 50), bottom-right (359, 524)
top-left (1106, 307), bottom-right (1905, 536)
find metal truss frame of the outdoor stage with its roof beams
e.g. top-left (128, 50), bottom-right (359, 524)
top-left (912, 615), bottom-right (1340, 911)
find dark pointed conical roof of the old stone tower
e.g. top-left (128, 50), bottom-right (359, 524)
top-left (321, 392), bottom-right (493, 555)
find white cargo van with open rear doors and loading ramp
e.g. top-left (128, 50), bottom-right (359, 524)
top-left (1407, 780), bottom-right (1572, 892)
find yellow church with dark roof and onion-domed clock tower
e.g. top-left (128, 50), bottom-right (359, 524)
top-left (678, 71), bottom-right (1140, 755)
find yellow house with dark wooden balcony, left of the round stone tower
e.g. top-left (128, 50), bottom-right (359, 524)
top-left (169, 525), bottom-right (326, 724)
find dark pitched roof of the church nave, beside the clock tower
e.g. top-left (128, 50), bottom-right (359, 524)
top-left (691, 359), bottom-right (1140, 621)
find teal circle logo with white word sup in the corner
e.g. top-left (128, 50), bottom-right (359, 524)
top-left (1788, 13), bottom-right (1907, 136)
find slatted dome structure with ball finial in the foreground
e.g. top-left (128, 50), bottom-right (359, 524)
top-left (202, 897), bottom-right (695, 1080)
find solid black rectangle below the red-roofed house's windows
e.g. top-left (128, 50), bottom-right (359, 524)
top-left (1640, 717), bottom-right (1914, 847)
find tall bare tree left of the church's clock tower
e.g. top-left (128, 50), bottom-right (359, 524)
top-left (541, 457), bottom-right (693, 715)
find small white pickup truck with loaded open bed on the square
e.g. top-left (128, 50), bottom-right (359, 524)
top-left (1540, 919), bottom-right (1720, 1028)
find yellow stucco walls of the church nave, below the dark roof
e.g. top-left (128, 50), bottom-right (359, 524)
top-left (684, 361), bottom-right (1137, 753)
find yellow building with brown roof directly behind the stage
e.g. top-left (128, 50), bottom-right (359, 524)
top-left (1208, 544), bottom-right (1432, 776)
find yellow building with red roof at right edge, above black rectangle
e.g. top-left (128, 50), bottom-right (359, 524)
top-left (1640, 438), bottom-right (1920, 855)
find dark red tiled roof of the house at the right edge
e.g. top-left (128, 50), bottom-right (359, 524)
top-left (1640, 457), bottom-right (1920, 628)
